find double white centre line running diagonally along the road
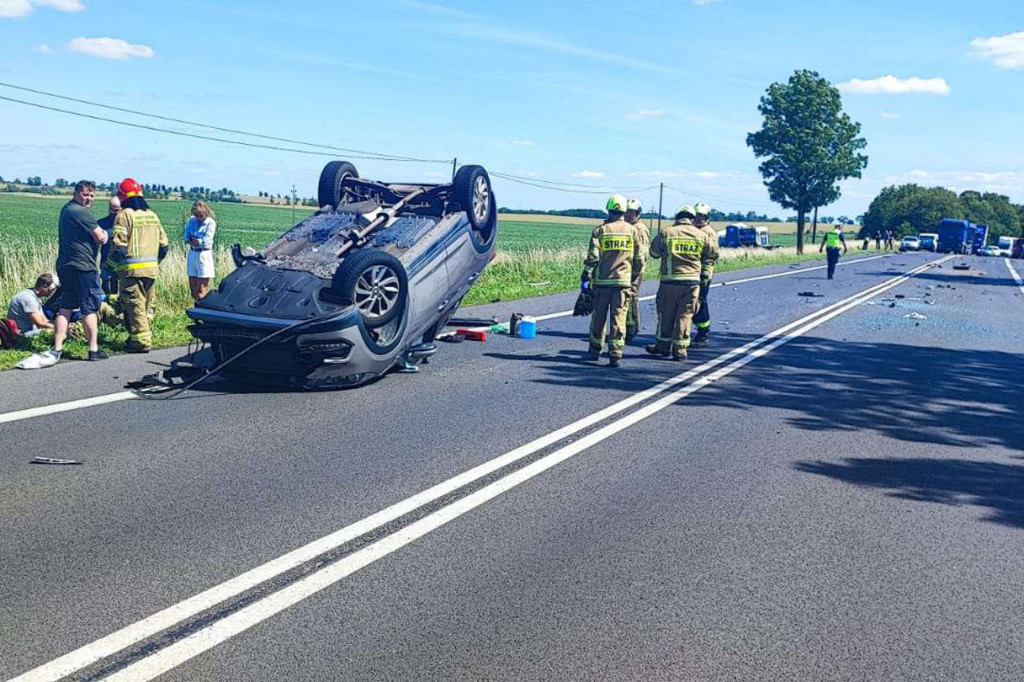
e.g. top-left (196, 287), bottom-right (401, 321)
top-left (10, 250), bottom-right (937, 682)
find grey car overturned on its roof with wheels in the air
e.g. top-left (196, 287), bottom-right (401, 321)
top-left (188, 161), bottom-right (498, 389)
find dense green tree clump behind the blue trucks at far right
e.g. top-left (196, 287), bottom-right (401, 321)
top-left (860, 183), bottom-right (1024, 238)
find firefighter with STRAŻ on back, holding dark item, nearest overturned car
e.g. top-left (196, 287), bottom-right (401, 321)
top-left (580, 195), bottom-right (642, 367)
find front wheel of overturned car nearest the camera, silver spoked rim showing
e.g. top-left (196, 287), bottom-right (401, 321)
top-left (331, 249), bottom-right (409, 329)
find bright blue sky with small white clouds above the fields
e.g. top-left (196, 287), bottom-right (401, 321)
top-left (0, 0), bottom-right (1024, 217)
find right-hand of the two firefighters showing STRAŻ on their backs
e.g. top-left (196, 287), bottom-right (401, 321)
top-left (645, 206), bottom-right (712, 360)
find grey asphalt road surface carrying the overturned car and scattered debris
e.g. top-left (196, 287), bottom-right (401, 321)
top-left (0, 254), bottom-right (1024, 682)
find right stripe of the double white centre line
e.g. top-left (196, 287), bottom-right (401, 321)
top-left (96, 253), bottom-right (948, 682)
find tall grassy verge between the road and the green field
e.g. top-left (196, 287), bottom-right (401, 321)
top-left (0, 242), bottom-right (864, 370)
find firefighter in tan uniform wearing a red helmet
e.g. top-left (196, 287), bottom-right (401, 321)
top-left (110, 178), bottom-right (167, 353)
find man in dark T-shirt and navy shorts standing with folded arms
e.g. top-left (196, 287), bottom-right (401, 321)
top-left (37, 180), bottom-right (108, 368)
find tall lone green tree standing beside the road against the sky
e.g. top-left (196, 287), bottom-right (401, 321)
top-left (746, 71), bottom-right (867, 253)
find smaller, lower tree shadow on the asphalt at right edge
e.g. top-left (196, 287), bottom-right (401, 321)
top-left (794, 459), bottom-right (1024, 527)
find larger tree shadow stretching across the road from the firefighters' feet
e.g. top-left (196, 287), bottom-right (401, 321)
top-left (488, 333), bottom-right (1024, 451)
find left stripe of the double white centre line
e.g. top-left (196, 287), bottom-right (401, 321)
top-left (4, 253), bottom-right (941, 682)
